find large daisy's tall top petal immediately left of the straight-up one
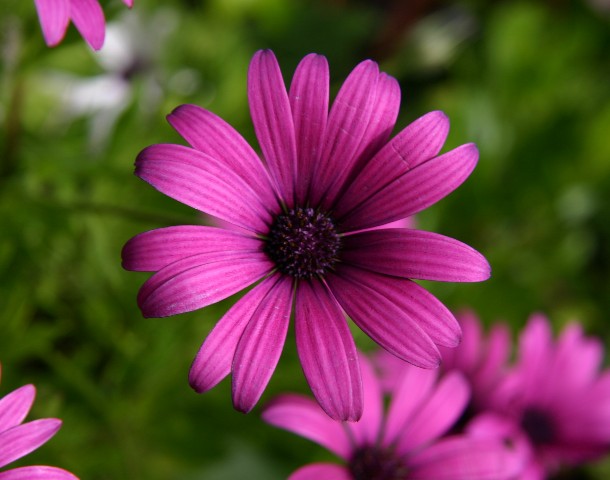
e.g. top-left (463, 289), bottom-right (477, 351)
top-left (248, 50), bottom-right (296, 206)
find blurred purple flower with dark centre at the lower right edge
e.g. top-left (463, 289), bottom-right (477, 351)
top-left (469, 314), bottom-right (610, 480)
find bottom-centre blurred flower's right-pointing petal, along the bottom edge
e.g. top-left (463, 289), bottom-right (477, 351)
top-left (409, 436), bottom-right (523, 480)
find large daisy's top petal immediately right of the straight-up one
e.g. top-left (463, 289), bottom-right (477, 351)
top-left (311, 60), bottom-right (379, 207)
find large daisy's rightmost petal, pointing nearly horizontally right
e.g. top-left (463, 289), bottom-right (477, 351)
top-left (342, 228), bottom-right (491, 282)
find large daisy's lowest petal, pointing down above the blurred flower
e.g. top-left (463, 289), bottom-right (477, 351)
top-left (295, 281), bottom-right (362, 421)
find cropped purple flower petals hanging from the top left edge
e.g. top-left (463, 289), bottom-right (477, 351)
top-left (34, 0), bottom-right (133, 50)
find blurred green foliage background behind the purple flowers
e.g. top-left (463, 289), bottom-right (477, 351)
top-left (0, 0), bottom-right (610, 480)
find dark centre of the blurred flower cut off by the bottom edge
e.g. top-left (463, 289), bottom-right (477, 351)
top-left (348, 446), bottom-right (407, 480)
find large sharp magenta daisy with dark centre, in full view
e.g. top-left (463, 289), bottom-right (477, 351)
top-left (123, 51), bottom-right (489, 420)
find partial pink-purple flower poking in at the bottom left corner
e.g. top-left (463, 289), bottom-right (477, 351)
top-left (0, 366), bottom-right (78, 480)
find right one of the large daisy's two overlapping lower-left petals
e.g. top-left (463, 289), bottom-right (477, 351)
top-left (232, 276), bottom-right (292, 412)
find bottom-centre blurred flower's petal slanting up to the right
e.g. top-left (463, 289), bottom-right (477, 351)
top-left (397, 372), bottom-right (470, 454)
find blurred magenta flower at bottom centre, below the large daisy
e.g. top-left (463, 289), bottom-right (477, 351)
top-left (263, 352), bottom-right (522, 480)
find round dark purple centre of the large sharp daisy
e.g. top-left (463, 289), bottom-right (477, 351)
top-left (265, 207), bottom-right (341, 278)
